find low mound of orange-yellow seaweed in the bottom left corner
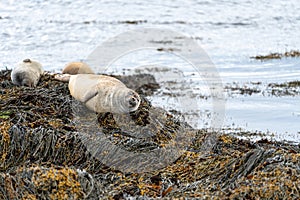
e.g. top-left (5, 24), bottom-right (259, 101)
top-left (0, 166), bottom-right (93, 199)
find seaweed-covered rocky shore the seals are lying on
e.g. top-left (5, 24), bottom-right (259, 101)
top-left (0, 70), bottom-right (300, 199)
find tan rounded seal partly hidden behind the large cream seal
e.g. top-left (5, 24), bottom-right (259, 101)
top-left (62, 62), bottom-right (95, 75)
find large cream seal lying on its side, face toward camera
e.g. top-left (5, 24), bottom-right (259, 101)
top-left (55, 74), bottom-right (141, 114)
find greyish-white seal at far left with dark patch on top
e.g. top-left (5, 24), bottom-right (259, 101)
top-left (11, 59), bottom-right (44, 87)
